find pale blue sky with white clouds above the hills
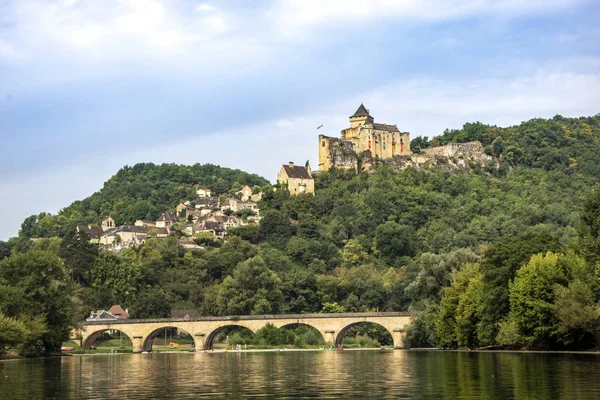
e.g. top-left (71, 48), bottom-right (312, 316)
top-left (0, 0), bottom-right (600, 240)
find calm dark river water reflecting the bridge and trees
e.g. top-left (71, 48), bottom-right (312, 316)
top-left (0, 351), bottom-right (600, 400)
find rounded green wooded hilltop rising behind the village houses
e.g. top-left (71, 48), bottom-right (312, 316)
top-left (20, 163), bottom-right (269, 238)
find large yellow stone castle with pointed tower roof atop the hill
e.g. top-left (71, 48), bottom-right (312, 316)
top-left (319, 103), bottom-right (411, 171)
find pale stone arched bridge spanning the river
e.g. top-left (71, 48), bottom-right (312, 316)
top-left (80, 312), bottom-right (410, 353)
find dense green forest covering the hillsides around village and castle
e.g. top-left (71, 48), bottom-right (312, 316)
top-left (0, 115), bottom-right (600, 354)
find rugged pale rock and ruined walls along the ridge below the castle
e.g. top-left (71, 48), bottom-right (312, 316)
top-left (332, 142), bottom-right (497, 173)
